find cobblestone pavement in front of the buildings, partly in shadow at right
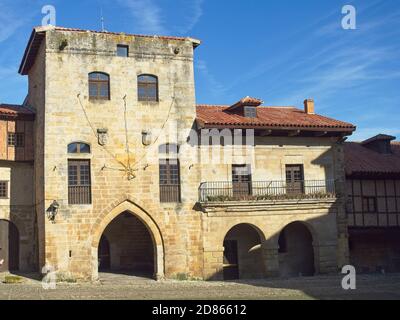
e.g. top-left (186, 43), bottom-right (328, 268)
top-left (0, 274), bottom-right (400, 300)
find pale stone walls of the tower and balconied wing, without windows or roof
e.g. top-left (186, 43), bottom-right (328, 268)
top-left (0, 28), bottom-right (354, 280)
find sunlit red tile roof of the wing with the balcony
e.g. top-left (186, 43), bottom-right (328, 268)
top-left (197, 105), bottom-right (355, 132)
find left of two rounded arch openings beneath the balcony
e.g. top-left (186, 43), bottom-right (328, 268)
top-left (223, 224), bottom-right (265, 280)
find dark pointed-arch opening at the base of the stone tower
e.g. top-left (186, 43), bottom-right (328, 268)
top-left (98, 212), bottom-right (155, 278)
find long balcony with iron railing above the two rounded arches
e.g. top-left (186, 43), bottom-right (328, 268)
top-left (199, 180), bottom-right (336, 203)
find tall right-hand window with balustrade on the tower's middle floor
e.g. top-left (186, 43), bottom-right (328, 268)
top-left (160, 159), bottom-right (181, 203)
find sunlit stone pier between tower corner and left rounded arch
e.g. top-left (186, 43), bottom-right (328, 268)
top-left (203, 247), bottom-right (224, 280)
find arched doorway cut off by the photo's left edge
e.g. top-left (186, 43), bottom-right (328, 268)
top-left (0, 220), bottom-right (19, 272)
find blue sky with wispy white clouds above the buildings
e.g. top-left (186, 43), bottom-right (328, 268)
top-left (0, 0), bottom-right (400, 140)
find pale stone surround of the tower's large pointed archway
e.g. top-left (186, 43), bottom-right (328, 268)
top-left (91, 200), bottom-right (164, 280)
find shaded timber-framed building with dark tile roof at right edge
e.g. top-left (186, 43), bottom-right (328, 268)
top-left (345, 134), bottom-right (400, 272)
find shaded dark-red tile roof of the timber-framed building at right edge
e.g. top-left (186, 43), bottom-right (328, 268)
top-left (344, 142), bottom-right (400, 176)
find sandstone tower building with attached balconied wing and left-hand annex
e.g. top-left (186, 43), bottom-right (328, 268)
top-left (0, 26), bottom-right (355, 279)
